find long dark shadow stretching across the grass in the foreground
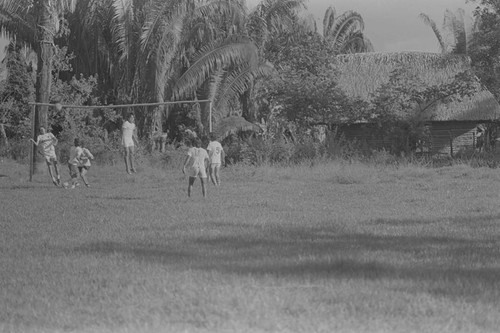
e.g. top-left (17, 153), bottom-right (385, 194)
top-left (67, 216), bottom-right (500, 295)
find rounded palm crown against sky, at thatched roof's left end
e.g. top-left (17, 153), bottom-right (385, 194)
top-left (323, 6), bottom-right (374, 54)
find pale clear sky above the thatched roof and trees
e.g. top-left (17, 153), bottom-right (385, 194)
top-left (247, 0), bottom-right (476, 52)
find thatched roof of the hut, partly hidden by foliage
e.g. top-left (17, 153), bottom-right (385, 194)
top-left (336, 52), bottom-right (500, 121)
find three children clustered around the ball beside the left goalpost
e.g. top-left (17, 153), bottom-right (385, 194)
top-left (31, 127), bottom-right (94, 188)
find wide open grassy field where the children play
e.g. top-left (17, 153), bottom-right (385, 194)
top-left (0, 156), bottom-right (500, 333)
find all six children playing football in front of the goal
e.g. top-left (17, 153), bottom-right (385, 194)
top-left (31, 123), bottom-right (225, 197)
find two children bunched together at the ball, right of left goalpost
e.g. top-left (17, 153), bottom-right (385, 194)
top-left (64, 139), bottom-right (94, 188)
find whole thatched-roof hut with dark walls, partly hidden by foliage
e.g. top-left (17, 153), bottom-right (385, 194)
top-left (336, 52), bottom-right (500, 154)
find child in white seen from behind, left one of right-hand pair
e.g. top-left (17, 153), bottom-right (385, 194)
top-left (182, 138), bottom-right (209, 198)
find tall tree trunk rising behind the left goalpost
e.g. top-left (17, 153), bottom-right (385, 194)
top-left (33, 0), bottom-right (56, 171)
